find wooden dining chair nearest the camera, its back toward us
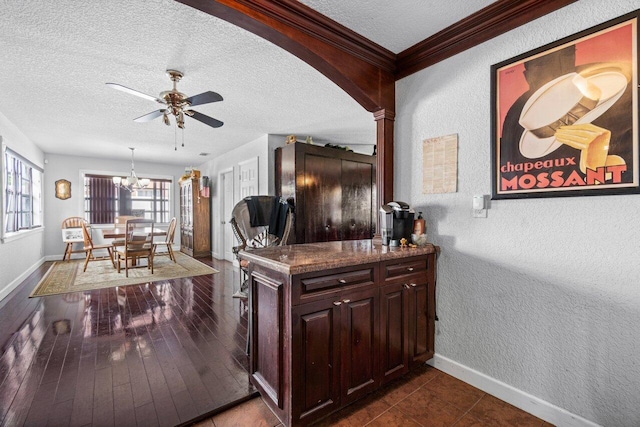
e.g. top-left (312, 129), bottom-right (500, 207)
top-left (115, 218), bottom-right (153, 277)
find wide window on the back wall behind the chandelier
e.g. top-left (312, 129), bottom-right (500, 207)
top-left (84, 174), bottom-right (171, 224)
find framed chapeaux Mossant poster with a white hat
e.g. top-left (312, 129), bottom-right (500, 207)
top-left (491, 11), bottom-right (640, 199)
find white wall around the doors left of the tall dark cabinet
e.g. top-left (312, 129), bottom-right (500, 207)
top-left (200, 135), bottom-right (284, 259)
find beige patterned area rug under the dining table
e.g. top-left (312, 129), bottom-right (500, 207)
top-left (29, 252), bottom-right (218, 297)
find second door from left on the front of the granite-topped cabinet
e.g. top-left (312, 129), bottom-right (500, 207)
top-left (340, 288), bottom-right (380, 406)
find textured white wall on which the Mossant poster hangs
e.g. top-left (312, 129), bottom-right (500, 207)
top-left (394, 0), bottom-right (640, 426)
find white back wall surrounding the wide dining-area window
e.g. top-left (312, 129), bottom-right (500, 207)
top-left (43, 154), bottom-right (184, 260)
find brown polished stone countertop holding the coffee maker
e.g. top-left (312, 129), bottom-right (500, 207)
top-left (240, 240), bottom-right (438, 274)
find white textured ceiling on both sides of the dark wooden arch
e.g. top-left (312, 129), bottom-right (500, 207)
top-left (0, 0), bottom-right (496, 165)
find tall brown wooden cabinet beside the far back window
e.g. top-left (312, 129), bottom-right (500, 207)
top-left (180, 179), bottom-right (211, 257)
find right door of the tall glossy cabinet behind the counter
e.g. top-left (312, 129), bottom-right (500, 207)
top-left (341, 160), bottom-right (375, 240)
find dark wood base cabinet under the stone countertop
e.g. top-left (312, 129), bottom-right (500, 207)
top-left (241, 242), bottom-right (435, 426)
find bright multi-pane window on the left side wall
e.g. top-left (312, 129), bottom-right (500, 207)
top-left (2, 147), bottom-right (43, 236)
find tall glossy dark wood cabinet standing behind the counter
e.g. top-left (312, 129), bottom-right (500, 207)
top-left (276, 143), bottom-right (377, 243)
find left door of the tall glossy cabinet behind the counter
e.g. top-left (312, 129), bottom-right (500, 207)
top-left (298, 154), bottom-right (342, 243)
